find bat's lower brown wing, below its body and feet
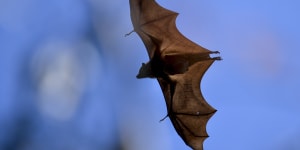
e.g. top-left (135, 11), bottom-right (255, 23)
top-left (158, 60), bottom-right (216, 150)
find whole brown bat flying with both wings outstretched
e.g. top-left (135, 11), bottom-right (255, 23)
top-left (129, 0), bottom-right (221, 150)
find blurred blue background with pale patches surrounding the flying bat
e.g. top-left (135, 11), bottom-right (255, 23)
top-left (0, 0), bottom-right (300, 150)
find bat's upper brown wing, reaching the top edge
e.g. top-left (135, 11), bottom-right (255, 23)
top-left (130, 0), bottom-right (211, 59)
